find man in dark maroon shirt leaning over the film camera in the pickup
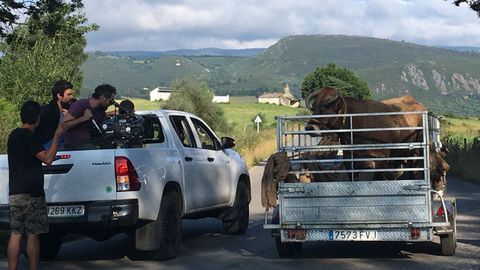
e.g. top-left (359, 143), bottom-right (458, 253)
top-left (64, 84), bottom-right (117, 150)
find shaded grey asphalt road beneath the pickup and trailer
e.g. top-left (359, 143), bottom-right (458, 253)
top-left (0, 163), bottom-right (480, 270)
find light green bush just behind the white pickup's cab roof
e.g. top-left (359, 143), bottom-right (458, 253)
top-left (163, 79), bottom-right (228, 131)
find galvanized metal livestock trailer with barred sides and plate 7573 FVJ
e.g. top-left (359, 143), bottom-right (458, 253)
top-left (264, 112), bottom-right (456, 257)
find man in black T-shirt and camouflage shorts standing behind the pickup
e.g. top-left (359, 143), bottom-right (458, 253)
top-left (7, 101), bottom-right (64, 269)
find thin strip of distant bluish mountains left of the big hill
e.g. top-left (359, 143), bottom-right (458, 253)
top-left (95, 48), bottom-right (265, 58)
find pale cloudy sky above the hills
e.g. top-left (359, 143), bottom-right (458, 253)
top-left (83, 0), bottom-right (480, 51)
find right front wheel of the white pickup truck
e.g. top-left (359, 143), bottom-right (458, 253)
top-left (223, 182), bottom-right (250, 234)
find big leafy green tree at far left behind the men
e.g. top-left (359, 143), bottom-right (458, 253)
top-left (0, 0), bottom-right (98, 105)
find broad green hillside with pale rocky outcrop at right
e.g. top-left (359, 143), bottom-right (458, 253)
top-left (83, 35), bottom-right (480, 116)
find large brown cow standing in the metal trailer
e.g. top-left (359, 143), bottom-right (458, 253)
top-left (305, 87), bottom-right (425, 180)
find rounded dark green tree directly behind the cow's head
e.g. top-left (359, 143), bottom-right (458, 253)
top-left (300, 63), bottom-right (371, 99)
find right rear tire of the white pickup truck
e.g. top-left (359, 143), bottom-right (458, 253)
top-left (142, 192), bottom-right (182, 260)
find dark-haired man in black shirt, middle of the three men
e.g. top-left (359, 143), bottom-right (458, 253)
top-left (35, 80), bottom-right (74, 149)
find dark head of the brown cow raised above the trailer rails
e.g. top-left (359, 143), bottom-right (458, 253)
top-left (305, 87), bottom-right (346, 136)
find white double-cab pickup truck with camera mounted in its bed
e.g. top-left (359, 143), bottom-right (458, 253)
top-left (0, 110), bottom-right (251, 259)
